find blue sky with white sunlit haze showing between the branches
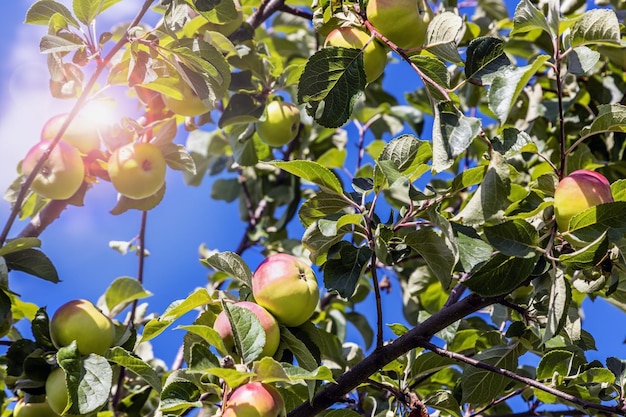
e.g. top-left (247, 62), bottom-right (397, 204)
top-left (0, 0), bottom-right (626, 390)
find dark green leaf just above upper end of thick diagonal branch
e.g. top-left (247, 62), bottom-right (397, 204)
top-left (465, 253), bottom-right (536, 297)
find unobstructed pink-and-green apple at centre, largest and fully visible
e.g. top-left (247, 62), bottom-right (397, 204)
top-left (252, 253), bottom-right (320, 327)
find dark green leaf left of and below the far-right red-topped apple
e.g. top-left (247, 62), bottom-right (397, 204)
top-left (485, 220), bottom-right (539, 258)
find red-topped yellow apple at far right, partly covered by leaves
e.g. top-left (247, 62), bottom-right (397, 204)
top-left (554, 169), bottom-right (613, 232)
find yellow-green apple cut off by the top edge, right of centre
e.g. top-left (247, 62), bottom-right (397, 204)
top-left (365, 0), bottom-right (433, 49)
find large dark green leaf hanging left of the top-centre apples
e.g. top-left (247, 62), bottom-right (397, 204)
top-left (298, 46), bottom-right (366, 127)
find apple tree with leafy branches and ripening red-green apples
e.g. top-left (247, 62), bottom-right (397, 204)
top-left (0, 0), bottom-right (626, 417)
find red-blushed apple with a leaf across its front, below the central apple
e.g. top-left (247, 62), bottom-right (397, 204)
top-left (213, 301), bottom-right (280, 357)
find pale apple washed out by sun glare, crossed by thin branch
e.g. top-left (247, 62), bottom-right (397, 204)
top-left (41, 113), bottom-right (100, 154)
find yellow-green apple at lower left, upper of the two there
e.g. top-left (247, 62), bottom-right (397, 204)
top-left (50, 299), bottom-right (115, 355)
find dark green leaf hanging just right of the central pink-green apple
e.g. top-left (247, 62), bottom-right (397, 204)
top-left (324, 240), bottom-right (372, 300)
